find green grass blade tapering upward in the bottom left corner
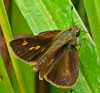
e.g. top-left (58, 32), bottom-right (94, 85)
top-left (0, 53), bottom-right (13, 93)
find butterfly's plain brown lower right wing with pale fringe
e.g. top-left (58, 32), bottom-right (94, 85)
top-left (45, 46), bottom-right (79, 88)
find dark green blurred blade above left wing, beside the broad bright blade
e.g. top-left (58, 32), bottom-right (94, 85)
top-left (9, 0), bottom-right (32, 35)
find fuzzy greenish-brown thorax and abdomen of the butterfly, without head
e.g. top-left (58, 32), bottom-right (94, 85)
top-left (34, 31), bottom-right (73, 72)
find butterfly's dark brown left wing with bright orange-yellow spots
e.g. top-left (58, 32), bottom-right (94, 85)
top-left (10, 30), bottom-right (60, 64)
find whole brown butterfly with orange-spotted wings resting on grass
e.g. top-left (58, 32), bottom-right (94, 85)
top-left (10, 26), bottom-right (81, 88)
